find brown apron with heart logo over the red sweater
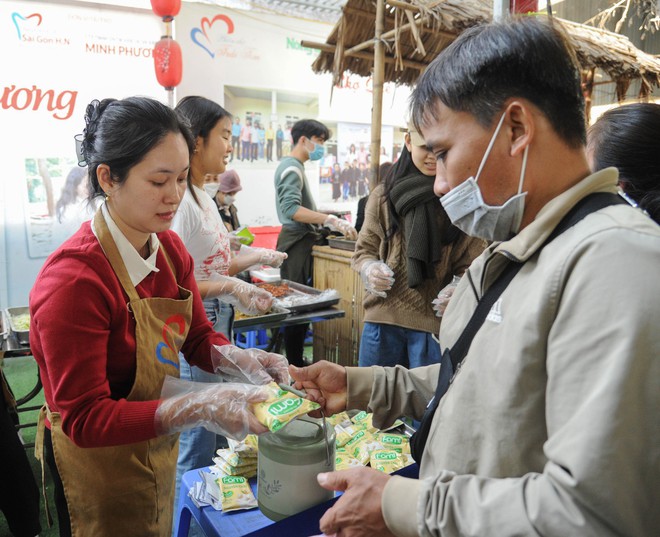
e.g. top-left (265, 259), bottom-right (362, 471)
top-left (36, 210), bottom-right (192, 537)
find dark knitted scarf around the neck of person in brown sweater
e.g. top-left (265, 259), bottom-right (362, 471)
top-left (390, 172), bottom-right (443, 289)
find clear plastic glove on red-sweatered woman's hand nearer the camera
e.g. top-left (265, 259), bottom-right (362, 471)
top-left (155, 377), bottom-right (270, 440)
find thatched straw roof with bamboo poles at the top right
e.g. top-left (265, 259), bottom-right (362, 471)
top-left (304, 0), bottom-right (660, 98)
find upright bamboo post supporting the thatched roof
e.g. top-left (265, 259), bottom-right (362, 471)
top-left (369, 0), bottom-right (385, 191)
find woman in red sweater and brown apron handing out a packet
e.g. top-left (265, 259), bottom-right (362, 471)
top-left (30, 97), bottom-right (287, 537)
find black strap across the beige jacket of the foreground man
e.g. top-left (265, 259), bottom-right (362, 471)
top-left (410, 192), bottom-right (628, 463)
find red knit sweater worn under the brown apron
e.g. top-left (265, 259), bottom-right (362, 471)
top-left (30, 222), bottom-right (229, 447)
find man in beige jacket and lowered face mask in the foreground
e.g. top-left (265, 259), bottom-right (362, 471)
top-left (289, 17), bottom-right (660, 537)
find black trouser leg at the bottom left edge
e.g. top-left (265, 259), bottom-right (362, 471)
top-left (0, 394), bottom-right (41, 537)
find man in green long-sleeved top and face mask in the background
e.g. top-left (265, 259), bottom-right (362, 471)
top-left (275, 119), bottom-right (357, 366)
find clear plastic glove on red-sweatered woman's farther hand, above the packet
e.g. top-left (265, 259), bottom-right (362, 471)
top-left (211, 345), bottom-right (289, 385)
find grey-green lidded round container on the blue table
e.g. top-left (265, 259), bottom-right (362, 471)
top-left (257, 416), bottom-right (335, 521)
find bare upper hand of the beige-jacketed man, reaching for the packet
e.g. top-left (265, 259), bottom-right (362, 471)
top-left (289, 360), bottom-right (347, 416)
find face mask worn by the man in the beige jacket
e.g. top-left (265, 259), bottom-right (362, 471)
top-left (440, 114), bottom-right (529, 241)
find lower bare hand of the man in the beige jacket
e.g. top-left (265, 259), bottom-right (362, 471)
top-left (317, 468), bottom-right (393, 537)
